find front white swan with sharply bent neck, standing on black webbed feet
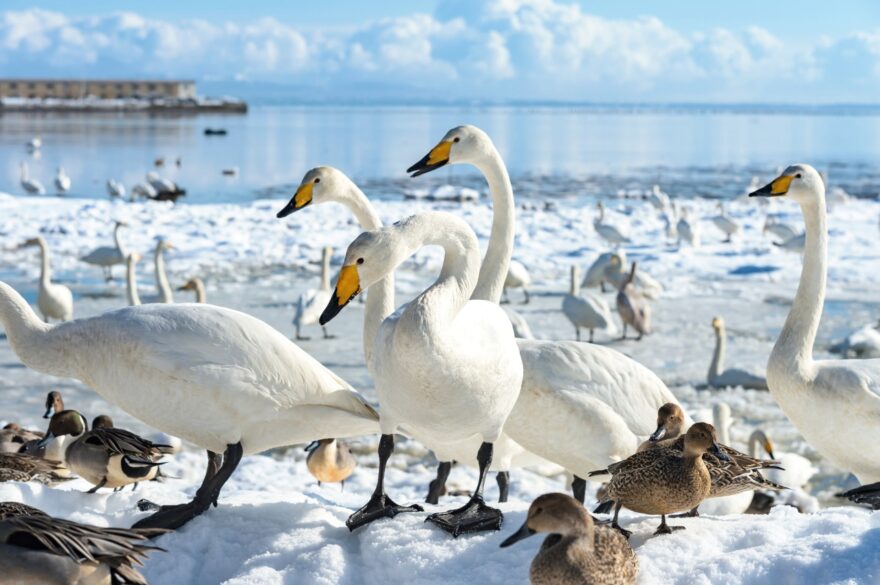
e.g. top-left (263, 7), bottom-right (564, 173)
top-left (321, 211), bottom-right (523, 536)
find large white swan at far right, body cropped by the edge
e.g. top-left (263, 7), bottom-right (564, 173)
top-left (752, 165), bottom-right (880, 483)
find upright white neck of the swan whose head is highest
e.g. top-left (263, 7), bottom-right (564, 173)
top-left (472, 147), bottom-right (516, 304)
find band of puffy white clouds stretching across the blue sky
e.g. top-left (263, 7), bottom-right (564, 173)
top-left (0, 0), bottom-right (880, 101)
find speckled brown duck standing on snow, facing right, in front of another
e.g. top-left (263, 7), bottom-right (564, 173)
top-left (590, 423), bottom-right (730, 537)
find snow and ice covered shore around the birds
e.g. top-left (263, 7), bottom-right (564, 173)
top-left (0, 188), bottom-right (880, 585)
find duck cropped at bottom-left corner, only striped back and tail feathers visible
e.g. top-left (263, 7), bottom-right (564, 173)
top-left (0, 502), bottom-right (164, 585)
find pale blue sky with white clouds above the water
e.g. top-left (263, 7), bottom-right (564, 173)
top-left (0, 0), bottom-right (880, 104)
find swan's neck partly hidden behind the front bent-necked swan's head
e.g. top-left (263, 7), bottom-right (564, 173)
top-left (338, 183), bottom-right (395, 366)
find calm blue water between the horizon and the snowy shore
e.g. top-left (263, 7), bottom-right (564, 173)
top-left (0, 106), bottom-right (880, 203)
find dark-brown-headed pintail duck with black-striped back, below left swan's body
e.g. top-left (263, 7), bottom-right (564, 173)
top-left (44, 410), bottom-right (170, 493)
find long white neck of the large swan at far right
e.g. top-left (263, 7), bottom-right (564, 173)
top-left (770, 195), bottom-right (828, 370)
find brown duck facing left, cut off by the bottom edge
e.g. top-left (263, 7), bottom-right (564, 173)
top-left (501, 494), bottom-right (639, 585)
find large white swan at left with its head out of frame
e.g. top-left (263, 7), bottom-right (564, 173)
top-left (0, 282), bottom-right (378, 528)
